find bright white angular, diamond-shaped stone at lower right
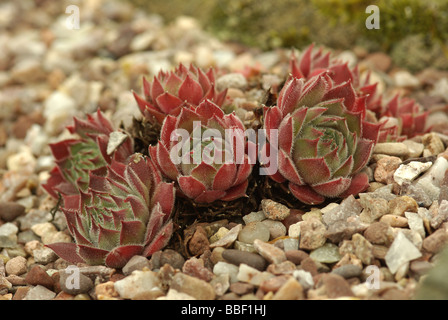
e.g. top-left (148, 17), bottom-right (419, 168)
top-left (385, 232), bottom-right (422, 274)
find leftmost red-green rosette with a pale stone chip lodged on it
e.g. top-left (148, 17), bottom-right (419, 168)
top-left (43, 109), bottom-right (133, 198)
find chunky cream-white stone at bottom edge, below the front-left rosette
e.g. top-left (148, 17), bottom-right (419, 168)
top-left (114, 270), bottom-right (163, 300)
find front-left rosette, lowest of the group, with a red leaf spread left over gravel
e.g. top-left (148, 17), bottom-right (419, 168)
top-left (48, 154), bottom-right (175, 268)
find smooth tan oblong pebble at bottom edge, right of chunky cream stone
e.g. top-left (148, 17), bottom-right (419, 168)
top-left (171, 273), bottom-right (216, 300)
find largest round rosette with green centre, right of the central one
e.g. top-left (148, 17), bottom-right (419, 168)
top-left (264, 73), bottom-right (379, 204)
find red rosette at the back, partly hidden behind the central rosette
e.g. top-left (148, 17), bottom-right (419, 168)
top-left (134, 64), bottom-right (227, 124)
